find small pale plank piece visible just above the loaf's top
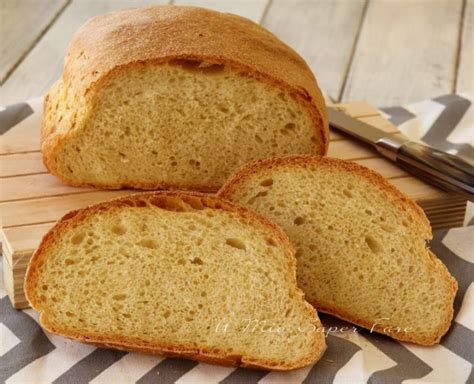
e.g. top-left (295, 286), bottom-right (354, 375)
top-left (173, 0), bottom-right (270, 23)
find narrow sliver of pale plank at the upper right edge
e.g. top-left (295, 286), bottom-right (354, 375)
top-left (456, 0), bottom-right (474, 94)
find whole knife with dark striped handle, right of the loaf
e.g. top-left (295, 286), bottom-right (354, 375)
top-left (328, 108), bottom-right (474, 201)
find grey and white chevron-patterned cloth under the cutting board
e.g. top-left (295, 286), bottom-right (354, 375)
top-left (0, 95), bottom-right (474, 384)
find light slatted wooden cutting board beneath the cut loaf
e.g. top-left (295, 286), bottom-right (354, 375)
top-left (0, 102), bottom-right (466, 308)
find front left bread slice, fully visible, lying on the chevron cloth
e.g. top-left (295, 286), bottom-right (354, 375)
top-left (25, 192), bottom-right (325, 370)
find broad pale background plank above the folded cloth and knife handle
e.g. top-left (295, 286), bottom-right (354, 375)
top-left (342, 0), bottom-right (462, 106)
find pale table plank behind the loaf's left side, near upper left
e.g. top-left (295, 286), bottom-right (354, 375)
top-left (2, 0), bottom-right (167, 105)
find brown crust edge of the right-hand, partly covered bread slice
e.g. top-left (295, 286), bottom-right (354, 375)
top-left (217, 155), bottom-right (458, 345)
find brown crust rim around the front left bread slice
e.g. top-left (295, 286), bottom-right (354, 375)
top-left (25, 191), bottom-right (325, 370)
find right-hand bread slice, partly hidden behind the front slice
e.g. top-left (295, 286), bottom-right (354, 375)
top-left (219, 156), bottom-right (457, 345)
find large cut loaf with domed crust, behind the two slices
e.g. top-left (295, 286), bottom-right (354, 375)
top-left (41, 6), bottom-right (328, 191)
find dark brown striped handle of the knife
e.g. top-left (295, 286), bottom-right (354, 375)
top-left (396, 141), bottom-right (474, 201)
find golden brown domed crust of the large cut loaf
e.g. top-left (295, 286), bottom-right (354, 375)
top-left (41, 6), bottom-right (329, 190)
